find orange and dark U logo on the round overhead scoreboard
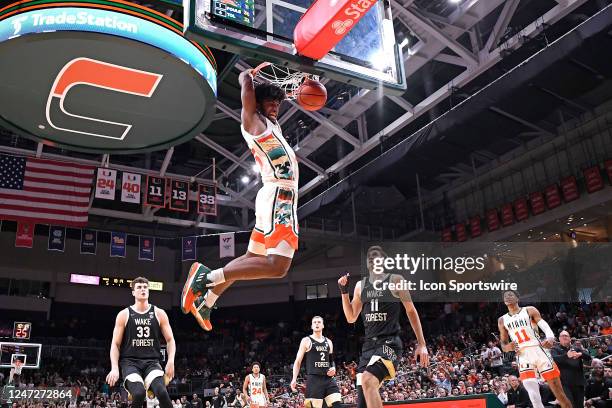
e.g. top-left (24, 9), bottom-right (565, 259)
top-left (46, 58), bottom-right (163, 140)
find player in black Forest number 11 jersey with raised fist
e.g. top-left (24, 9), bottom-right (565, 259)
top-left (338, 246), bottom-right (429, 408)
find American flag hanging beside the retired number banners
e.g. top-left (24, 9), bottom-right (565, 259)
top-left (0, 155), bottom-right (95, 227)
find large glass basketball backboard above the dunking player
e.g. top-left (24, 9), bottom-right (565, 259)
top-left (184, 0), bottom-right (406, 95)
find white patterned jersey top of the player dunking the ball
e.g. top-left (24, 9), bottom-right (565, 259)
top-left (240, 118), bottom-right (299, 188)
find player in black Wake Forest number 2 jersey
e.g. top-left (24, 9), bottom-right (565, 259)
top-left (291, 316), bottom-right (342, 408)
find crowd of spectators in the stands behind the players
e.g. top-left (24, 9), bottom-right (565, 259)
top-left (5, 303), bottom-right (612, 408)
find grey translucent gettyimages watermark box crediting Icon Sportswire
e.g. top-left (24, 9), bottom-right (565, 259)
top-left (362, 242), bottom-right (612, 302)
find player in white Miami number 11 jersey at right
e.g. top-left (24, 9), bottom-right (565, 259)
top-left (497, 290), bottom-right (572, 408)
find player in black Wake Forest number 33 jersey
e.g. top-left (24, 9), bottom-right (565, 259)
top-left (106, 277), bottom-right (176, 408)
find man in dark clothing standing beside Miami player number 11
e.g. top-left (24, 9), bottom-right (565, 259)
top-left (551, 330), bottom-right (591, 408)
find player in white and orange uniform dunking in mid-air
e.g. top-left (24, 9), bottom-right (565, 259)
top-left (181, 64), bottom-right (298, 330)
